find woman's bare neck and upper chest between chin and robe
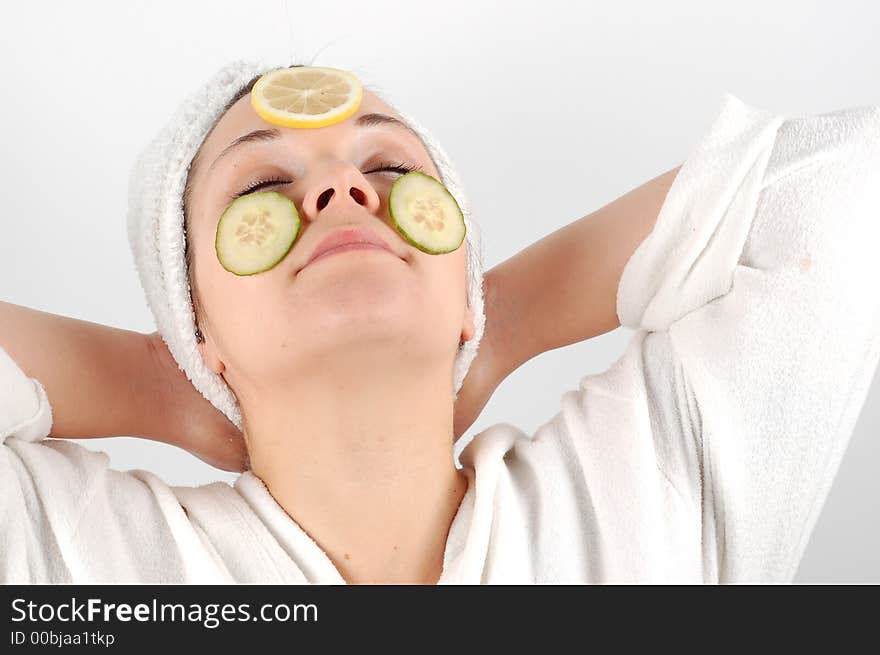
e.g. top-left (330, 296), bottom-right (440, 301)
top-left (234, 361), bottom-right (468, 584)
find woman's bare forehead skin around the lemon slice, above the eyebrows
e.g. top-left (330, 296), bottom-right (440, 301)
top-left (200, 89), bottom-right (402, 159)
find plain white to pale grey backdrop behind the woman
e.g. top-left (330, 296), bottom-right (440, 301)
top-left (0, 0), bottom-right (880, 582)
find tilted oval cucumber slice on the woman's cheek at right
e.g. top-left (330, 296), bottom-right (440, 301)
top-left (388, 171), bottom-right (466, 255)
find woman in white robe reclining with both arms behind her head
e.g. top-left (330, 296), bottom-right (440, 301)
top-left (0, 60), bottom-right (880, 583)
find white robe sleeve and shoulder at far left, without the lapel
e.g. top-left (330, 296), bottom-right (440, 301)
top-left (0, 348), bottom-right (219, 584)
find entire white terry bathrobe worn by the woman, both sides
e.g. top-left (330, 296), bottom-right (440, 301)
top-left (0, 94), bottom-right (880, 584)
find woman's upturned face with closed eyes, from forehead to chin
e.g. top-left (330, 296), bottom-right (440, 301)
top-left (188, 90), bottom-right (474, 401)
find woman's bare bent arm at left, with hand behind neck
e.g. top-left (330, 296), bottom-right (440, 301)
top-left (0, 302), bottom-right (244, 470)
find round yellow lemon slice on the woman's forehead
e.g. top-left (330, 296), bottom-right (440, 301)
top-left (251, 66), bottom-right (364, 127)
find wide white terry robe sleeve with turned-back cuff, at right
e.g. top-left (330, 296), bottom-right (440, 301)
top-left (617, 94), bottom-right (880, 582)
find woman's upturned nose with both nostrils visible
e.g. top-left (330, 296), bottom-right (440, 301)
top-left (302, 162), bottom-right (381, 222)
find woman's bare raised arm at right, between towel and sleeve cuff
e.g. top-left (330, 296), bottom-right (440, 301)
top-left (475, 166), bottom-right (680, 388)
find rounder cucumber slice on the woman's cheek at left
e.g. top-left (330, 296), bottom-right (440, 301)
top-left (214, 191), bottom-right (301, 275)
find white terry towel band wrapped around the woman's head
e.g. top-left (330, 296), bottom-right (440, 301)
top-left (128, 59), bottom-right (486, 430)
